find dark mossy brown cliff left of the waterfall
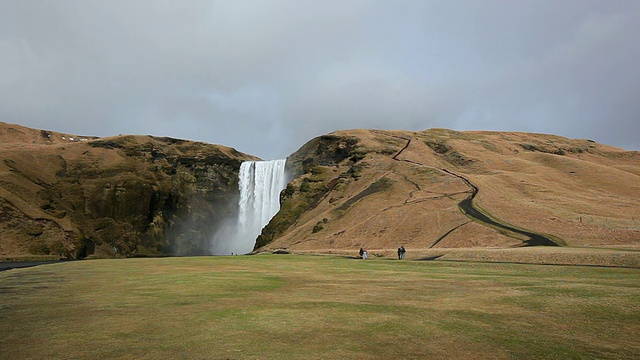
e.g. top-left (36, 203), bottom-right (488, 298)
top-left (0, 123), bottom-right (256, 259)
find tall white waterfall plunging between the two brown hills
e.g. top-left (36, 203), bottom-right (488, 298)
top-left (211, 159), bottom-right (287, 255)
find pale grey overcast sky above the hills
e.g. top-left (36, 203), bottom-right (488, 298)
top-left (0, 0), bottom-right (640, 159)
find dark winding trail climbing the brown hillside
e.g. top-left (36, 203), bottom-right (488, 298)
top-left (386, 134), bottom-right (559, 248)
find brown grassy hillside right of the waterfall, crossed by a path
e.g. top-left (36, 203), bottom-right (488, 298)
top-left (256, 129), bottom-right (640, 256)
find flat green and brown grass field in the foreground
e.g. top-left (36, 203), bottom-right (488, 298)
top-left (0, 255), bottom-right (640, 359)
